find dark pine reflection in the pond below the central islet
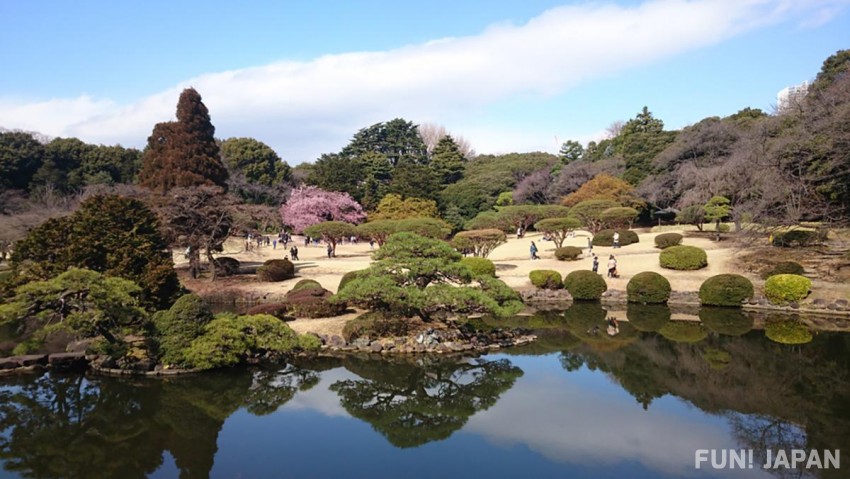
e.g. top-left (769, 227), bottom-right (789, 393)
top-left (331, 357), bottom-right (522, 448)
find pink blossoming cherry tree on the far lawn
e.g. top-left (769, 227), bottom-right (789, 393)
top-left (280, 186), bottom-right (366, 233)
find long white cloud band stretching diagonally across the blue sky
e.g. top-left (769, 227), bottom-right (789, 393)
top-left (0, 0), bottom-right (847, 163)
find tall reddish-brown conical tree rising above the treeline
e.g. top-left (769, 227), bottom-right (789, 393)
top-left (139, 88), bottom-right (228, 192)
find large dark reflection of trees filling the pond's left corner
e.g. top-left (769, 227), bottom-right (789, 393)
top-left (0, 366), bottom-right (319, 479)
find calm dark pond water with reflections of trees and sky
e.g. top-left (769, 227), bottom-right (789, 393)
top-left (0, 306), bottom-right (850, 479)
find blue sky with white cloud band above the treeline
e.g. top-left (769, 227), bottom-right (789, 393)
top-left (0, 0), bottom-right (850, 164)
